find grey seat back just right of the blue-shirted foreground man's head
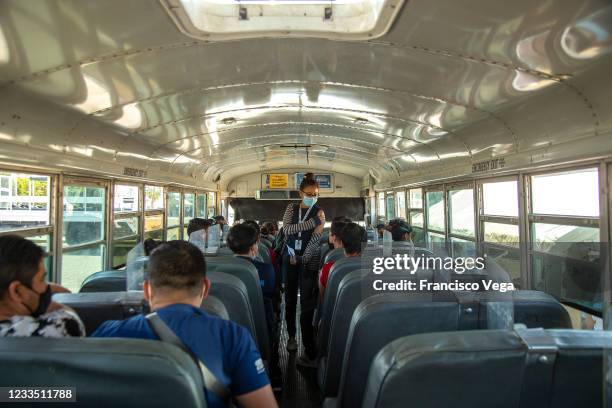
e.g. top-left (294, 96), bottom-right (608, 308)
top-left (207, 271), bottom-right (259, 346)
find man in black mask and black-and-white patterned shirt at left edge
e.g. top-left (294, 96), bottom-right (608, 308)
top-left (0, 235), bottom-right (85, 337)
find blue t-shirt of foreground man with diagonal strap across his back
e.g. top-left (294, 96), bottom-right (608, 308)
top-left (91, 303), bottom-right (270, 408)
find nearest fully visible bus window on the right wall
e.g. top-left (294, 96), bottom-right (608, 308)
top-left (529, 168), bottom-right (602, 312)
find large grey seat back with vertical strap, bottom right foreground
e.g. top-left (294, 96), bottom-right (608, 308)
top-left (361, 329), bottom-right (612, 408)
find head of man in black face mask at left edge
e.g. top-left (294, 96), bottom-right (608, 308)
top-left (0, 235), bottom-right (51, 317)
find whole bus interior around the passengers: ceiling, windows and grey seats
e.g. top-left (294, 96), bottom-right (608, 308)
top-left (0, 0), bottom-right (612, 408)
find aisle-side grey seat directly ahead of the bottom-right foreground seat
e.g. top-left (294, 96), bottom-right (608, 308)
top-left (326, 286), bottom-right (462, 398)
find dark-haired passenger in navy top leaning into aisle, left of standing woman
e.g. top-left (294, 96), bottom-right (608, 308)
top-left (227, 225), bottom-right (282, 390)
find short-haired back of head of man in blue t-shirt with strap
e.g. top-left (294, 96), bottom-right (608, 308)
top-left (143, 241), bottom-right (210, 308)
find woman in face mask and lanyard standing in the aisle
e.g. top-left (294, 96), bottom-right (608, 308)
top-left (282, 173), bottom-right (325, 365)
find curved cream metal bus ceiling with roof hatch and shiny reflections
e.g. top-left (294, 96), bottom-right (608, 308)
top-left (0, 0), bottom-right (612, 189)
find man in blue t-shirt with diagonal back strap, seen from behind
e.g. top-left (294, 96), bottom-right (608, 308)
top-left (92, 241), bottom-right (277, 408)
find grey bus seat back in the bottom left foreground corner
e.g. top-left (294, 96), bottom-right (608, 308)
top-left (0, 337), bottom-right (206, 408)
